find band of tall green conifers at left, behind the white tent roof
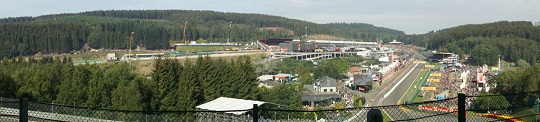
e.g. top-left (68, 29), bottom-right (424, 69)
top-left (0, 56), bottom-right (301, 111)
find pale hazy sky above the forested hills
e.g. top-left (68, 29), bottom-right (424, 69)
top-left (0, 0), bottom-right (540, 34)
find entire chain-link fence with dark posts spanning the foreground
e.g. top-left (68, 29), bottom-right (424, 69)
top-left (0, 92), bottom-right (540, 122)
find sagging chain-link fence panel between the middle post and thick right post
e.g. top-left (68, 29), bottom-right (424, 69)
top-left (260, 98), bottom-right (458, 122)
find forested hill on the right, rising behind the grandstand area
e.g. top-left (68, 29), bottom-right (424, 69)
top-left (428, 21), bottom-right (540, 65)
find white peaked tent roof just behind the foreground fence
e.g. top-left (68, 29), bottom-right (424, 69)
top-left (196, 97), bottom-right (268, 115)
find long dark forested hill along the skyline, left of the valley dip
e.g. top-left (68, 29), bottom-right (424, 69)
top-left (0, 10), bottom-right (404, 57)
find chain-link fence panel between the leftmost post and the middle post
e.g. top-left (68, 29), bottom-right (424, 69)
top-left (24, 102), bottom-right (252, 122)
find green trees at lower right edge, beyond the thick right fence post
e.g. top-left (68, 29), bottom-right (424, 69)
top-left (475, 64), bottom-right (540, 121)
